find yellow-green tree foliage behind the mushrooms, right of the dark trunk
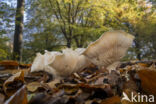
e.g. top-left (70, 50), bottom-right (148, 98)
top-left (23, 0), bottom-right (156, 59)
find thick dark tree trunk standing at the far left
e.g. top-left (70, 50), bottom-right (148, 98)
top-left (13, 0), bottom-right (24, 61)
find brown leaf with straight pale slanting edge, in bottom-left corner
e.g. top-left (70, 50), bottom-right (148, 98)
top-left (4, 85), bottom-right (28, 104)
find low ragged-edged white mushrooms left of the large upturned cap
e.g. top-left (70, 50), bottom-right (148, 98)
top-left (31, 48), bottom-right (90, 78)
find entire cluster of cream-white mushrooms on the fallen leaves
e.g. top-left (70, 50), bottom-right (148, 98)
top-left (31, 30), bottom-right (134, 78)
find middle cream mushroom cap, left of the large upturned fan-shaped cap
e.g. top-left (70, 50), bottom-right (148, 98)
top-left (50, 48), bottom-right (90, 77)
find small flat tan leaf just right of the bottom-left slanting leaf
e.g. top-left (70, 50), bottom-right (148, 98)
top-left (26, 82), bottom-right (41, 92)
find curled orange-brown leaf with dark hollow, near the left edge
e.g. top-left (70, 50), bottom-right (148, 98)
top-left (3, 71), bottom-right (24, 96)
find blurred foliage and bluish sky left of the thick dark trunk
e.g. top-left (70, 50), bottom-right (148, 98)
top-left (0, 1), bottom-right (14, 60)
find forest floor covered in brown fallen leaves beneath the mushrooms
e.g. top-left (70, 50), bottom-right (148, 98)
top-left (0, 61), bottom-right (156, 104)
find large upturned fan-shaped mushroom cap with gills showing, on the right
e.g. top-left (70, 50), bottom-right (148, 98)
top-left (83, 30), bottom-right (134, 71)
